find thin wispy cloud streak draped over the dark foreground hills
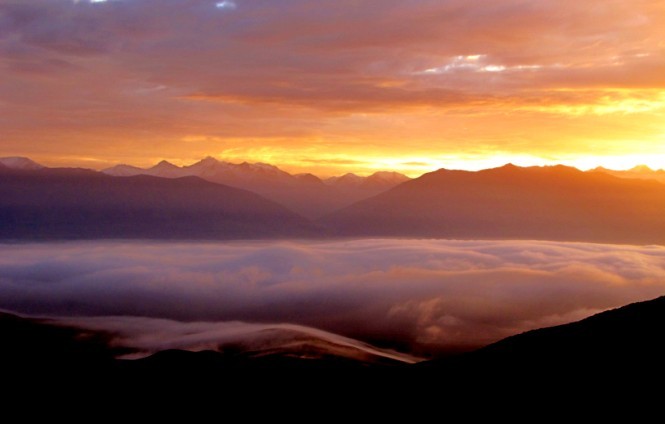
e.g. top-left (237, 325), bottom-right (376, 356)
top-left (66, 317), bottom-right (422, 364)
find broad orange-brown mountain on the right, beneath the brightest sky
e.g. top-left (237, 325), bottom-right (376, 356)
top-left (320, 165), bottom-right (665, 244)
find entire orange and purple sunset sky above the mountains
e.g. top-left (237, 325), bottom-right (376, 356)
top-left (0, 0), bottom-right (665, 176)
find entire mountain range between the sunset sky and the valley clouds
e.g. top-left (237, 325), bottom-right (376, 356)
top-left (0, 158), bottom-right (665, 244)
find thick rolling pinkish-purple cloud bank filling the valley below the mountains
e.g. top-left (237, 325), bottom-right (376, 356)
top-left (0, 240), bottom-right (665, 354)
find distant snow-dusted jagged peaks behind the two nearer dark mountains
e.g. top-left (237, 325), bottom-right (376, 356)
top-left (101, 157), bottom-right (409, 219)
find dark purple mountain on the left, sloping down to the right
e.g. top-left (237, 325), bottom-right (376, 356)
top-left (0, 169), bottom-right (316, 239)
